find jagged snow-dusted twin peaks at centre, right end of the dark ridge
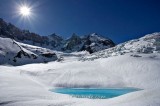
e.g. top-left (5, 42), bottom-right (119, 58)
top-left (63, 33), bottom-right (115, 53)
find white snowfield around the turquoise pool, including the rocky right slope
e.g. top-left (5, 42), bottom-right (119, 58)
top-left (0, 33), bottom-right (160, 106)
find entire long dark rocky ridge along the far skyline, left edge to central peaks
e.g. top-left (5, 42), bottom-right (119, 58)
top-left (0, 18), bottom-right (115, 53)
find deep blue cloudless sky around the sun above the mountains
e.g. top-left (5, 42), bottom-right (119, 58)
top-left (0, 0), bottom-right (160, 43)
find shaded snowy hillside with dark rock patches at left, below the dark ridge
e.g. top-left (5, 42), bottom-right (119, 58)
top-left (0, 37), bottom-right (57, 65)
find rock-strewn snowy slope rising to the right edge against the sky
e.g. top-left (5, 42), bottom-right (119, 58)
top-left (82, 32), bottom-right (160, 60)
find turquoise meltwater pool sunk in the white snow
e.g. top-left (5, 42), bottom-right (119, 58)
top-left (51, 88), bottom-right (140, 99)
